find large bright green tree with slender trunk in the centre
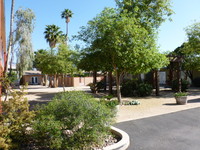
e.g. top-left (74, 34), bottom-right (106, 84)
top-left (78, 8), bottom-right (167, 102)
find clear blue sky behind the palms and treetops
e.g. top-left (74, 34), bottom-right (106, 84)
top-left (5, 0), bottom-right (200, 52)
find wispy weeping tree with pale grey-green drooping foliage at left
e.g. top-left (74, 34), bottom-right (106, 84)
top-left (15, 8), bottom-right (35, 78)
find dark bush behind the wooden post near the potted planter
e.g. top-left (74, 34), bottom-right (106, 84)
top-left (172, 79), bottom-right (189, 92)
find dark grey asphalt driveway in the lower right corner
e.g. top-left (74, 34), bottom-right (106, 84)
top-left (115, 108), bottom-right (200, 150)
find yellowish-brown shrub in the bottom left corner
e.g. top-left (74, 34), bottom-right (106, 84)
top-left (0, 88), bottom-right (34, 149)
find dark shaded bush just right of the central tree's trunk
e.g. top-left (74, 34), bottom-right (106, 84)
top-left (121, 80), bottom-right (153, 97)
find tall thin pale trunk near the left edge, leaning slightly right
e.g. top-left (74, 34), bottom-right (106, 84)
top-left (4, 0), bottom-right (15, 76)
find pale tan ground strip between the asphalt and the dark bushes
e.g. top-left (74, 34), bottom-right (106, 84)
top-left (117, 91), bottom-right (200, 122)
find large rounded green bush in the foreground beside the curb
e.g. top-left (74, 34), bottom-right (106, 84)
top-left (33, 91), bottom-right (115, 149)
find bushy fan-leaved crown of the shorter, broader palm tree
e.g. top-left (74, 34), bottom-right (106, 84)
top-left (44, 24), bottom-right (63, 48)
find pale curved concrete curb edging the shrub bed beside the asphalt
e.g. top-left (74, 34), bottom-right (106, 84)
top-left (103, 126), bottom-right (130, 150)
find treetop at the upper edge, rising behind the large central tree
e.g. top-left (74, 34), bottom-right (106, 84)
top-left (115, 0), bottom-right (173, 30)
